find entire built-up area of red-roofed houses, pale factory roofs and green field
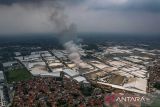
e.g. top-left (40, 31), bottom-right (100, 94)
top-left (0, 45), bottom-right (160, 107)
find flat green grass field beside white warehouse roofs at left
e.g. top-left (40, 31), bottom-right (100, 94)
top-left (5, 68), bottom-right (32, 83)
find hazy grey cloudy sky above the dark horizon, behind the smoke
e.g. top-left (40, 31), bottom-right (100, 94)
top-left (0, 0), bottom-right (160, 34)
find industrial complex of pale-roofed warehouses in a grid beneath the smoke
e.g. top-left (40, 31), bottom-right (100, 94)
top-left (13, 47), bottom-right (154, 94)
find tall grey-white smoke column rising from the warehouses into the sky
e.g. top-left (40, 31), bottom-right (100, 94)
top-left (50, 2), bottom-right (83, 66)
